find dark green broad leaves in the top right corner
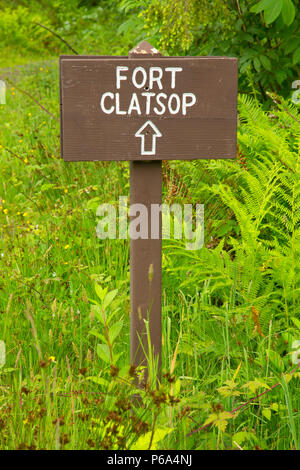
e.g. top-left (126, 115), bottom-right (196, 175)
top-left (225, 0), bottom-right (300, 98)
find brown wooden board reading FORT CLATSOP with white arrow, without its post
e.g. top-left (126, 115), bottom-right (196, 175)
top-left (60, 48), bottom-right (237, 161)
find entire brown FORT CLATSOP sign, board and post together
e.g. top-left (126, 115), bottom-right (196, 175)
top-left (60, 41), bottom-right (237, 382)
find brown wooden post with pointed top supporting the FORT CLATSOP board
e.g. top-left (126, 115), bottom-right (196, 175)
top-left (129, 41), bottom-right (162, 377)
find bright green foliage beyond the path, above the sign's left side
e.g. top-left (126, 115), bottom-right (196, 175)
top-left (0, 0), bottom-right (136, 66)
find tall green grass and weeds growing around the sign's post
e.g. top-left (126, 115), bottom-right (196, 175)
top-left (0, 53), bottom-right (300, 449)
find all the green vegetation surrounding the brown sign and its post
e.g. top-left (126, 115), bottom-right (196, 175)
top-left (0, 0), bottom-right (300, 449)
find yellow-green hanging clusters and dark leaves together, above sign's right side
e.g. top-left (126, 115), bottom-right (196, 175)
top-left (137, 0), bottom-right (300, 98)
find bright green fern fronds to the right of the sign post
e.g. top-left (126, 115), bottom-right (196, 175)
top-left (168, 92), bottom-right (300, 335)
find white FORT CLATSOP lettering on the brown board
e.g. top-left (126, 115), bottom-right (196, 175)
top-left (100, 65), bottom-right (197, 116)
